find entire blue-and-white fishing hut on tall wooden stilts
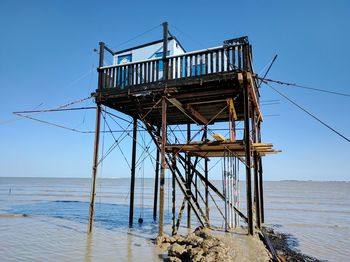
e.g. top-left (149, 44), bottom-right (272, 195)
top-left (88, 23), bottom-right (277, 235)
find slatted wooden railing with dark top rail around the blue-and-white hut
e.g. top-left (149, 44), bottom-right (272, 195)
top-left (99, 44), bottom-right (251, 91)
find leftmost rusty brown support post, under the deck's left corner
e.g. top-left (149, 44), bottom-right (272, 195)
top-left (88, 104), bottom-right (101, 233)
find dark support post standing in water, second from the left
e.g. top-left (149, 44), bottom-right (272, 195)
top-left (129, 117), bottom-right (137, 227)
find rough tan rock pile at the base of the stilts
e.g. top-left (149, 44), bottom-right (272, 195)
top-left (156, 228), bottom-right (232, 262)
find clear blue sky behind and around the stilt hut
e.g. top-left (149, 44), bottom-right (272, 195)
top-left (0, 0), bottom-right (350, 180)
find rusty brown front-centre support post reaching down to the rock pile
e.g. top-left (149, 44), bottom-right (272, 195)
top-left (159, 96), bottom-right (167, 236)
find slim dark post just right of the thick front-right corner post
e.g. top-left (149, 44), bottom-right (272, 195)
top-left (251, 105), bottom-right (261, 228)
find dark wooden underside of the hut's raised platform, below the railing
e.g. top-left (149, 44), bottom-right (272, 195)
top-left (94, 71), bottom-right (261, 125)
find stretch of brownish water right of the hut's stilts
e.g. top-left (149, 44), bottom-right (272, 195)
top-left (265, 181), bottom-right (350, 261)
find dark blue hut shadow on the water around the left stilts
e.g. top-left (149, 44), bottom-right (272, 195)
top-left (6, 201), bottom-right (170, 234)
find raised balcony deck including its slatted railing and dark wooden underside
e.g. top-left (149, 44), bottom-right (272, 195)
top-left (94, 44), bottom-right (261, 125)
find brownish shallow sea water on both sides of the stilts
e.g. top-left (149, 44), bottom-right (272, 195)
top-left (0, 178), bottom-right (350, 261)
